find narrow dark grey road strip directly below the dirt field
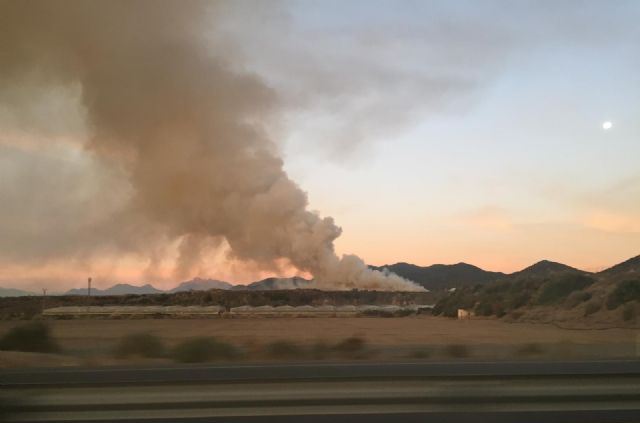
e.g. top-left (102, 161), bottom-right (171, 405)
top-left (5, 360), bottom-right (640, 387)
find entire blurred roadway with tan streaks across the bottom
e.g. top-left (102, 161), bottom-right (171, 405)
top-left (0, 361), bottom-right (640, 423)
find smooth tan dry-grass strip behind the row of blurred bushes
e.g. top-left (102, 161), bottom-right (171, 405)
top-left (0, 316), bottom-right (637, 349)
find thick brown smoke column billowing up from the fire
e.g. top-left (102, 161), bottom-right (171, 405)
top-left (0, 0), bottom-right (422, 290)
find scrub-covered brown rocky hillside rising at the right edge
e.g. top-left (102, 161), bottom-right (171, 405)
top-left (434, 257), bottom-right (640, 327)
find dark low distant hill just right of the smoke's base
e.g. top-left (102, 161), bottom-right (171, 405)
top-left (371, 263), bottom-right (505, 291)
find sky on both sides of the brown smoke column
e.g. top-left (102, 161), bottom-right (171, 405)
top-left (0, 0), bottom-right (640, 289)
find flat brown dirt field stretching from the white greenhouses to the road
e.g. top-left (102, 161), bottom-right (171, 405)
top-left (0, 316), bottom-right (640, 366)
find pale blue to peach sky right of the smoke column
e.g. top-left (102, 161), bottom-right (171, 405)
top-left (225, 1), bottom-right (640, 271)
